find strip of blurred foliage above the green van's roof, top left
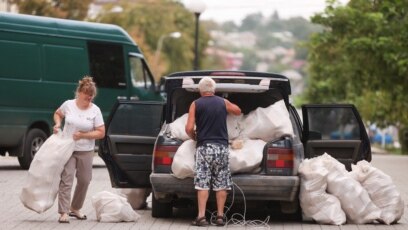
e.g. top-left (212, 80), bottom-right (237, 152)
top-left (10, 0), bottom-right (92, 20)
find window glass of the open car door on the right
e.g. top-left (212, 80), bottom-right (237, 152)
top-left (308, 107), bottom-right (361, 140)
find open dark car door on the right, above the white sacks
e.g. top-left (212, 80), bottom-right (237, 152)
top-left (302, 104), bottom-right (371, 170)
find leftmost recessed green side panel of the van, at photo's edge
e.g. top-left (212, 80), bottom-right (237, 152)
top-left (0, 40), bottom-right (41, 80)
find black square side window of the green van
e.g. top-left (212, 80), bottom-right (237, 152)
top-left (88, 42), bottom-right (126, 88)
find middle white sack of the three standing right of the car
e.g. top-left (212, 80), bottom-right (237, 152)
top-left (322, 153), bottom-right (381, 224)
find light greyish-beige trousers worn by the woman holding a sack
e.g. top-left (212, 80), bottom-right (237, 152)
top-left (58, 151), bottom-right (94, 214)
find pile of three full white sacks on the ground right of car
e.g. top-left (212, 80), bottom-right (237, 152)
top-left (299, 153), bottom-right (404, 225)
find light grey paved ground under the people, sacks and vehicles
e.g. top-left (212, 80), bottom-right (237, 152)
top-left (0, 154), bottom-right (408, 230)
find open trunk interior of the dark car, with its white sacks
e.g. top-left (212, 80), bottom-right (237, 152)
top-left (165, 88), bottom-right (302, 179)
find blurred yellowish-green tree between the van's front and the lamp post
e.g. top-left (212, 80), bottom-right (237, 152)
top-left (95, 0), bottom-right (209, 78)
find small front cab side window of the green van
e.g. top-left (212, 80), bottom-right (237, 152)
top-left (129, 56), bottom-right (152, 89)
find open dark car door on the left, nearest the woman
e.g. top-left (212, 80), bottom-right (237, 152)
top-left (98, 100), bottom-right (164, 188)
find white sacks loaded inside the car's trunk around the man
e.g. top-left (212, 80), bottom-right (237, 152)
top-left (169, 100), bottom-right (293, 179)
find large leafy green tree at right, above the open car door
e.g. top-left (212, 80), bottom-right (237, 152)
top-left (306, 0), bottom-right (408, 130)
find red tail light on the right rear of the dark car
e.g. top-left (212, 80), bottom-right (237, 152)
top-left (264, 139), bottom-right (295, 176)
